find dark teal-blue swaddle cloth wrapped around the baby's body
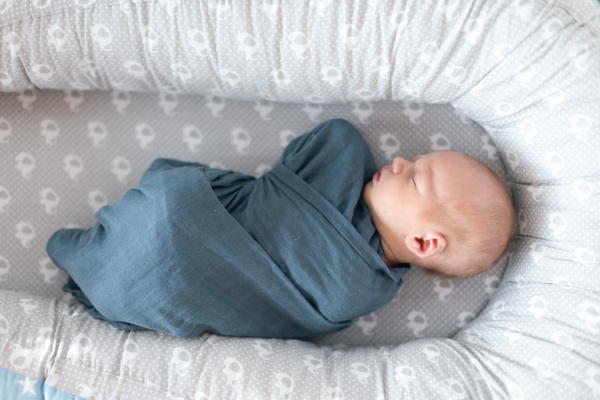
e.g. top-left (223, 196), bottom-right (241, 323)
top-left (46, 119), bottom-right (410, 338)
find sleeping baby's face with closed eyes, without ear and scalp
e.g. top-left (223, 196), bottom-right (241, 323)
top-left (363, 151), bottom-right (495, 270)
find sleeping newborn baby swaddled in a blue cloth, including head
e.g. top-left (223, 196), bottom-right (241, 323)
top-left (46, 119), bottom-right (516, 338)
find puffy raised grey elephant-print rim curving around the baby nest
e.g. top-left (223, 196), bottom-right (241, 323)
top-left (0, 0), bottom-right (600, 399)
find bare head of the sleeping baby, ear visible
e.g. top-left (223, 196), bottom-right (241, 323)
top-left (363, 151), bottom-right (517, 278)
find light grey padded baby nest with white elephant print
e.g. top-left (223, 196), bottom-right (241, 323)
top-left (0, 0), bottom-right (600, 400)
